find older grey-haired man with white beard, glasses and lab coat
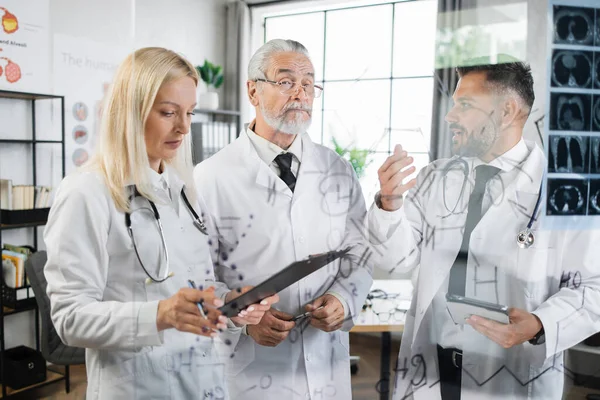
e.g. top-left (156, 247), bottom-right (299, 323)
top-left (194, 39), bottom-right (372, 400)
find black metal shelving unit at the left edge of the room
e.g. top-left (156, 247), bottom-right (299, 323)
top-left (0, 90), bottom-right (68, 398)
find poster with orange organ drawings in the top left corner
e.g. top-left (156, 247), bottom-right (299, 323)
top-left (0, 0), bottom-right (50, 93)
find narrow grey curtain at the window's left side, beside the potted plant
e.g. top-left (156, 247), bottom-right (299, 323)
top-left (224, 0), bottom-right (251, 128)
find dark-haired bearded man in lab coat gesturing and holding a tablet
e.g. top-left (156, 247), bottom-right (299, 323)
top-left (369, 60), bottom-right (600, 400)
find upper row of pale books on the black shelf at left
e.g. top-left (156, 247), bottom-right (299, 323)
top-left (0, 184), bottom-right (52, 210)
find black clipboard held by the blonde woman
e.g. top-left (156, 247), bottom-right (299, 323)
top-left (219, 248), bottom-right (350, 317)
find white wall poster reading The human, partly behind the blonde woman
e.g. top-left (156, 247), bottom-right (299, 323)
top-left (54, 34), bottom-right (129, 173)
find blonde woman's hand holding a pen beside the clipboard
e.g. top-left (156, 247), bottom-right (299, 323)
top-left (156, 287), bottom-right (227, 337)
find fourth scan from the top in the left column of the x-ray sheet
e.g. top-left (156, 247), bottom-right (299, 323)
top-left (548, 135), bottom-right (589, 174)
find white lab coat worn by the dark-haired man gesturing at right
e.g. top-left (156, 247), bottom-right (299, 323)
top-left (369, 142), bottom-right (600, 400)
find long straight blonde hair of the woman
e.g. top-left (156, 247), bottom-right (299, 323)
top-left (86, 47), bottom-right (198, 211)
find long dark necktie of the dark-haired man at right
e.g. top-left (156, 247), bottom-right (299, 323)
top-left (448, 165), bottom-right (500, 296)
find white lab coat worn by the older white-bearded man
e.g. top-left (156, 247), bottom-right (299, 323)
top-left (194, 132), bottom-right (372, 400)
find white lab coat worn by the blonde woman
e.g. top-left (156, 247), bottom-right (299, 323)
top-left (44, 167), bottom-right (228, 400)
